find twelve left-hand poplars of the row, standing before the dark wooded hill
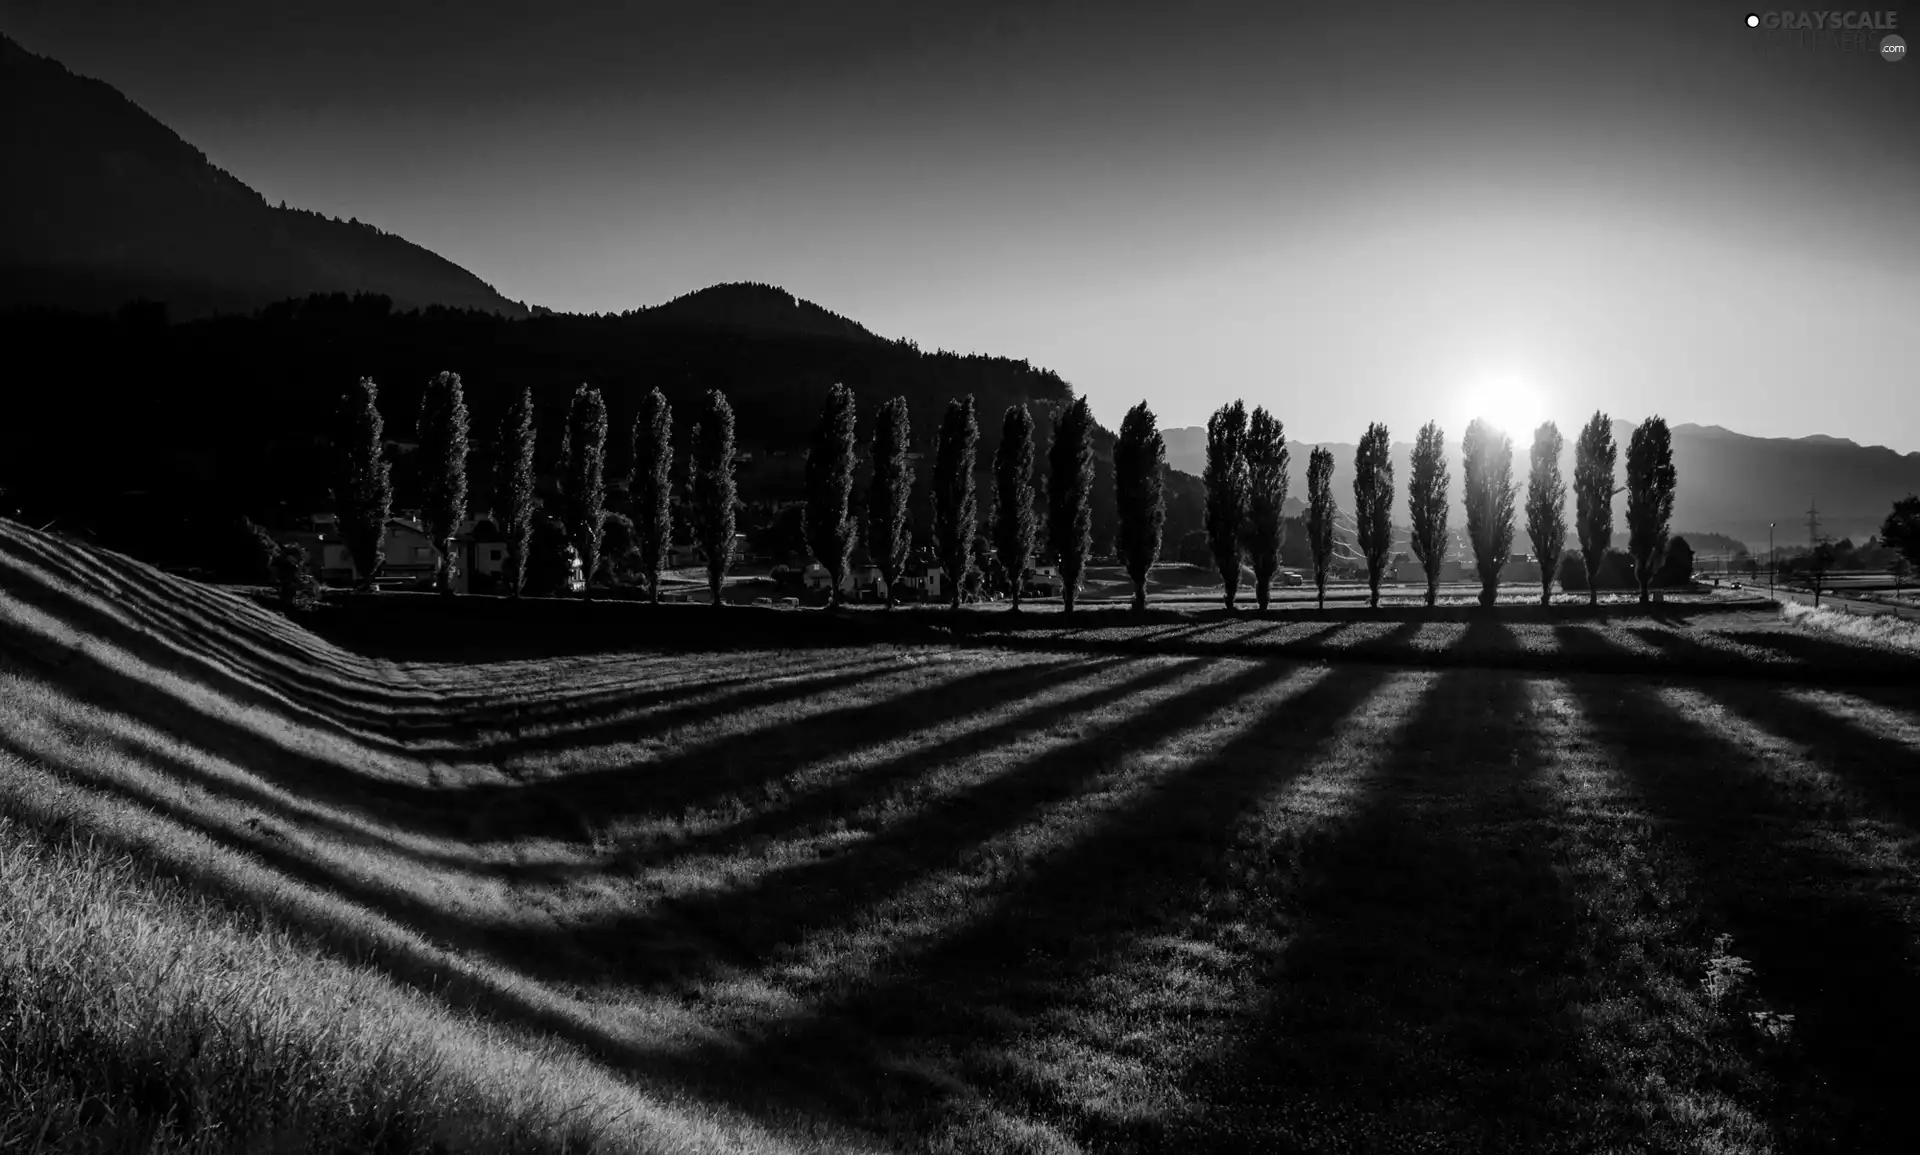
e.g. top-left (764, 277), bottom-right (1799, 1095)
top-left (334, 372), bottom-right (1136, 612)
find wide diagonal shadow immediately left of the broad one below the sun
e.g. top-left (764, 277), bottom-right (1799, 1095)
top-left (675, 652), bottom-right (1386, 1149)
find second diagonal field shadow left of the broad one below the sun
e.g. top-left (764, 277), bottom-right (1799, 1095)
top-left (476, 662), bottom-right (1244, 986)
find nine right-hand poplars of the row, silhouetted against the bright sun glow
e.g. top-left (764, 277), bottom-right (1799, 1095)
top-left (1204, 401), bottom-right (1676, 610)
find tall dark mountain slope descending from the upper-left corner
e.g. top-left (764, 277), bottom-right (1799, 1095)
top-left (0, 36), bottom-right (526, 317)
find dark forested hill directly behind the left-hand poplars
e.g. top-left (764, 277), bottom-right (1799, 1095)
top-left (0, 290), bottom-right (1108, 556)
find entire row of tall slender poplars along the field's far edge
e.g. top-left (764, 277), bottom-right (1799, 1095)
top-left (334, 372), bottom-right (1674, 612)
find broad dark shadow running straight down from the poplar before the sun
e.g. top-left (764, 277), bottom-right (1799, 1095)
top-left (1140, 627), bottom-right (1644, 1153)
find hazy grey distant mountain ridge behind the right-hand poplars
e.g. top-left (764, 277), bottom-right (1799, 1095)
top-left (1164, 420), bottom-right (1920, 549)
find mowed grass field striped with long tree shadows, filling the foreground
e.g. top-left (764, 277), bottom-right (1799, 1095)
top-left (0, 522), bottom-right (1920, 1151)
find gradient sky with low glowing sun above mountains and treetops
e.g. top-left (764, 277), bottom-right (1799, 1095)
top-left (11, 0), bottom-right (1920, 453)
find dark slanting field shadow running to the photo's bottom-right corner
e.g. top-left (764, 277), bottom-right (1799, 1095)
top-left (1569, 648), bottom-right (1920, 1151)
